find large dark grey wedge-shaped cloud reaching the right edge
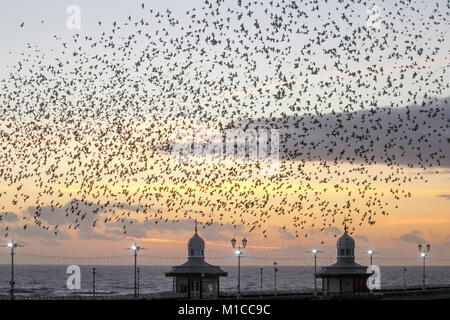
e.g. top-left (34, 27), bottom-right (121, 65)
top-left (229, 99), bottom-right (450, 168)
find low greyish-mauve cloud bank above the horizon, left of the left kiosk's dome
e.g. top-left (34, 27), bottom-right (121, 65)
top-left (14, 199), bottom-right (250, 241)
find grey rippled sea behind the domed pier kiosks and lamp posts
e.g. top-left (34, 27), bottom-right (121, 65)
top-left (0, 264), bottom-right (450, 298)
